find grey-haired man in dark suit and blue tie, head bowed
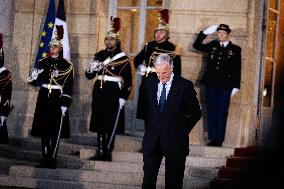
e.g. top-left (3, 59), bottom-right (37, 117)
top-left (142, 54), bottom-right (201, 189)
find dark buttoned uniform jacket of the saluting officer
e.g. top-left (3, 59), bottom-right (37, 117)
top-left (193, 32), bottom-right (241, 89)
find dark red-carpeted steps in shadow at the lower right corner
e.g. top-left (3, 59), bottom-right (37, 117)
top-left (210, 146), bottom-right (284, 189)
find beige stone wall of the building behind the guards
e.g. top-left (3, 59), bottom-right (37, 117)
top-left (0, 0), bottom-right (262, 146)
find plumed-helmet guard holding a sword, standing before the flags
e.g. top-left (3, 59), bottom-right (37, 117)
top-left (28, 26), bottom-right (74, 168)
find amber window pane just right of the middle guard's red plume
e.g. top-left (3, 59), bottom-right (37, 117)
top-left (117, 10), bottom-right (139, 53)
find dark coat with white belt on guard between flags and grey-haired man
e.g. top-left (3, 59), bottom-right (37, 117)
top-left (85, 47), bottom-right (132, 134)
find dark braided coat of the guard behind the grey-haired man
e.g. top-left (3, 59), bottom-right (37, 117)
top-left (134, 39), bottom-right (181, 120)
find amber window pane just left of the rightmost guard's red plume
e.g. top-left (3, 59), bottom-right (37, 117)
top-left (144, 10), bottom-right (159, 42)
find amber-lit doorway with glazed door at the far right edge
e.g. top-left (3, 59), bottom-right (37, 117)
top-left (256, 0), bottom-right (284, 144)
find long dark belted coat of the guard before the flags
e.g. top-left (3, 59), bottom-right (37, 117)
top-left (31, 56), bottom-right (74, 138)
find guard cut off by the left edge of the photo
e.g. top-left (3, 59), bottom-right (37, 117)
top-left (0, 33), bottom-right (12, 144)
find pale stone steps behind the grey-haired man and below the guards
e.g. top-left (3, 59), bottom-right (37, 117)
top-left (0, 133), bottom-right (234, 189)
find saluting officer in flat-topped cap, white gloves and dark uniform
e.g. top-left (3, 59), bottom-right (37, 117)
top-left (193, 24), bottom-right (241, 146)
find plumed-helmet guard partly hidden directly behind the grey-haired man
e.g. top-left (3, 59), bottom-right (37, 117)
top-left (134, 9), bottom-right (181, 128)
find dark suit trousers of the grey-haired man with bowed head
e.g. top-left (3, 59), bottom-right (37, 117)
top-left (142, 139), bottom-right (186, 189)
